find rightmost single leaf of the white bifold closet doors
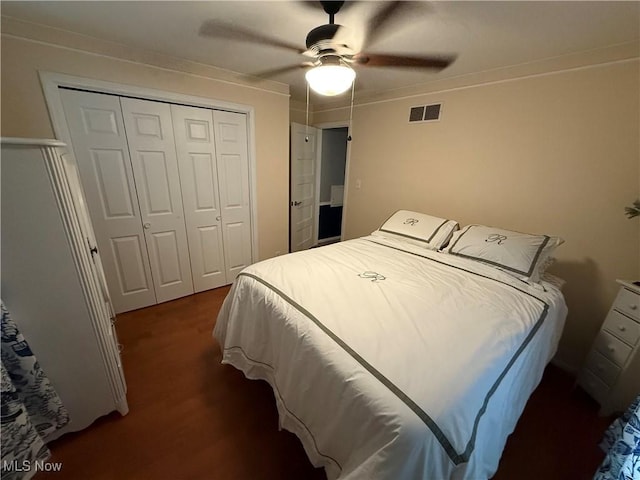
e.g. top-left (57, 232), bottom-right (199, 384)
top-left (213, 110), bottom-right (252, 282)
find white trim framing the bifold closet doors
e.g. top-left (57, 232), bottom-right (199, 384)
top-left (38, 71), bottom-right (258, 263)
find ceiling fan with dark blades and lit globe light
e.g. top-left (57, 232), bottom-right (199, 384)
top-left (200, 1), bottom-right (455, 95)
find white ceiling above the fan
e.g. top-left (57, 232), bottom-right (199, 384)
top-left (0, 0), bottom-right (640, 101)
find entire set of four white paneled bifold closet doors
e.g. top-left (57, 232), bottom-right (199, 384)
top-left (47, 77), bottom-right (254, 313)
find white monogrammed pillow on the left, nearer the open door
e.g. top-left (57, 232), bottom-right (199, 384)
top-left (373, 210), bottom-right (459, 250)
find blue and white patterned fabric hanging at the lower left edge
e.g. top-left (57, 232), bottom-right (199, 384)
top-left (0, 301), bottom-right (69, 480)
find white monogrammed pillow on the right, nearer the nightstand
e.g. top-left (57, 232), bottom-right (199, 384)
top-left (445, 225), bottom-right (564, 283)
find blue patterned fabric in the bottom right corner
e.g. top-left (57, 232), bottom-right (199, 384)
top-left (593, 396), bottom-right (640, 480)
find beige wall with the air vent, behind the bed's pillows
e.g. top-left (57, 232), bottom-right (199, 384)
top-left (314, 59), bottom-right (640, 368)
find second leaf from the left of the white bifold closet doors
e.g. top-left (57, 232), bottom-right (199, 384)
top-left (120, 98), bottom-right (194, 302)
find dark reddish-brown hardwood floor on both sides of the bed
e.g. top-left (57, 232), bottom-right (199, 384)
top-left (36, 288), bottom-right (611, 480)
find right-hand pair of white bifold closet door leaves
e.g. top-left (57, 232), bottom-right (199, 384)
top-left (171, 105), bottom-right (252, 286)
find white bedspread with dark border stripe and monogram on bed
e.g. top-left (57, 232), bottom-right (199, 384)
top-left (214, 236), bottom-right (567, 480)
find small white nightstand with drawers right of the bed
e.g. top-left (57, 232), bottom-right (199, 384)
top-left (578, 280), bottom-right (640, 415)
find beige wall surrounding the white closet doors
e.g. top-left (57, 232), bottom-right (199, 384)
top-left (1, 22), bottom-right (289, 259)
